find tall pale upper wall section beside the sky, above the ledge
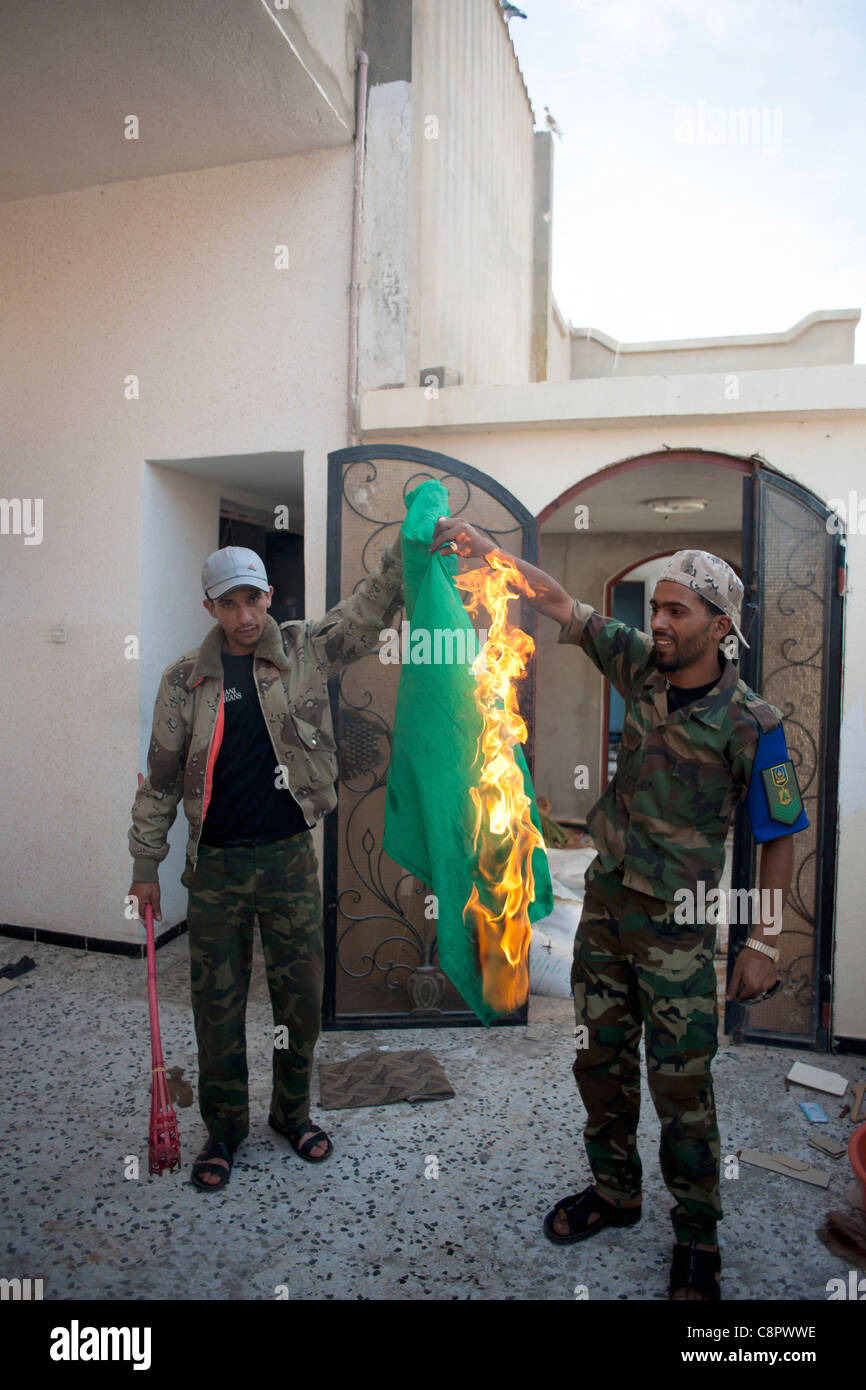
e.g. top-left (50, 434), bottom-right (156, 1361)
top-left (406, 0), bottom-right (534, 385)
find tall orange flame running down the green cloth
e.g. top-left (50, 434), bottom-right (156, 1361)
top-left (455, 555), bottom-right (544, 1013)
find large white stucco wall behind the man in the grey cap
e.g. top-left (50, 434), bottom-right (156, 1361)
top-left (0, 147), bottom-right (352, 941)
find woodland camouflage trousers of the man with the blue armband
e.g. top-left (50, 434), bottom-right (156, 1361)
top-left (571, 858), bottom-right (721, 1244)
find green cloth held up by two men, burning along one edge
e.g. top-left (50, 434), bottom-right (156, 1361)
top-left (384, 481), bottom-right (553, 1024)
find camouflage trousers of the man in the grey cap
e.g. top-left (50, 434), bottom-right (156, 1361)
top-left (183, 831), bottom-right (324, 1144)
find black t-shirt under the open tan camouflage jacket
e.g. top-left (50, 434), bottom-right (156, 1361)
top-left (202, 652), bottom-right (309, 847)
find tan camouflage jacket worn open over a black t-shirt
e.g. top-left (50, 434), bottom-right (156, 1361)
top-left (129, 537), bottom-right (403, 883)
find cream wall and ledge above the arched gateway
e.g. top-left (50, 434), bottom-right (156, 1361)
top-left (363, 405), bottom-right (866, 1038)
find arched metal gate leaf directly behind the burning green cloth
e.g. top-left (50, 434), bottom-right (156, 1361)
top-left (322, 445), bottom-right (538, 1029)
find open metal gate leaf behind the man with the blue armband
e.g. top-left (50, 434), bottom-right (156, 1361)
top-left (726, 467), bottom-right (845, 1049)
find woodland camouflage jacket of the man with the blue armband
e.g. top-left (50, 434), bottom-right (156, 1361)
top-left (559, 603), bottom-right (781, 902)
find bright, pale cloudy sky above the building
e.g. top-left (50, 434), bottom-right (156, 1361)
top-left (510, 0), bottom-right (866, 361)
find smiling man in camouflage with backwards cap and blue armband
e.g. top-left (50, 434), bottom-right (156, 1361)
top-left (434, 521), bottom-right (808, 1298)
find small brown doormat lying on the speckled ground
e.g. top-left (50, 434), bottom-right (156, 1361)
top-left (318, 1048), bottom-right (455, 1111)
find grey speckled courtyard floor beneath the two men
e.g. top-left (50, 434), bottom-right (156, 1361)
top-left (0, 935), bottom-right (866, 1301)
